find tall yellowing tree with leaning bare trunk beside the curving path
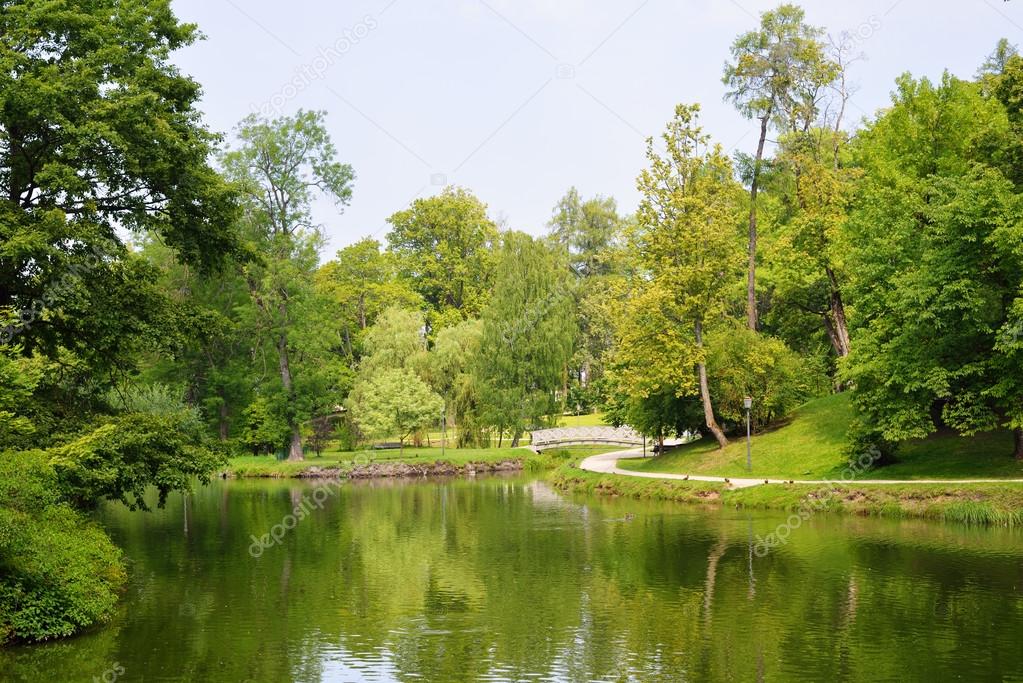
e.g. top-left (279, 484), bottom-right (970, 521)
top-left (636, 104), bottom-right (741, 448)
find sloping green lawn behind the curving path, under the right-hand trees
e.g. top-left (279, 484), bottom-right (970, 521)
top-left (619, 394), bottom-right (1023, 480)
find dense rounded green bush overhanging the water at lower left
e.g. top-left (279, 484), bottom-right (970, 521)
top-left (0, 451), bottom-right (125, 643)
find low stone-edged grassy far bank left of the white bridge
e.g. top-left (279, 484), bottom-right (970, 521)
top-left (227, 447), bottom-right (619, 477)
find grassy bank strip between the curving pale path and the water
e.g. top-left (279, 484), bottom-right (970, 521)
top-left (551, 465), bottom-right (1023, 527)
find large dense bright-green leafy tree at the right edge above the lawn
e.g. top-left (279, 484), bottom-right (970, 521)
top-left (845, 75), bottom-right (1023, 457)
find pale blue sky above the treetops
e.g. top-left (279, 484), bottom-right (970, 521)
top-left (174, 0), bottom-right (1023, 258)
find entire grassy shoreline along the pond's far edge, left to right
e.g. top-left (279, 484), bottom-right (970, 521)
top-left (220, 451), bottom-right (1023, 527)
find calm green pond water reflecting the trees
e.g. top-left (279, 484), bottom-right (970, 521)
top-left (0, 477), bottom-right (1023, 683)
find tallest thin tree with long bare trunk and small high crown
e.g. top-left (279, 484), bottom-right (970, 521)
top-left (723, 4), bottom-right (836, 330)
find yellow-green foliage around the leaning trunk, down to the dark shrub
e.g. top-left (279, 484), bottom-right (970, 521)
top-left (609, 105), bottom-right (743, 435)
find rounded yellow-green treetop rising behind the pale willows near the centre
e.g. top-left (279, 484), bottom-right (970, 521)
top-left (387, 187), bottom-right (497, 330)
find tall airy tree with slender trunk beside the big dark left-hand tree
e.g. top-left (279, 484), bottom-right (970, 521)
top-left (223, 111), bottom-right (355, 460)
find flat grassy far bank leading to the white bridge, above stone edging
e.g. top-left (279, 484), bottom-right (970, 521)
top-left (225, 447), bottom-right (619, 479)
